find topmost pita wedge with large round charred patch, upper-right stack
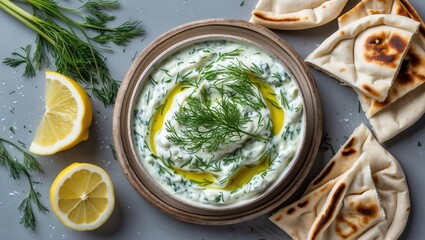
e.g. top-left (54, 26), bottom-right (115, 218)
top-left (305, 14), bottom-right (419, 102)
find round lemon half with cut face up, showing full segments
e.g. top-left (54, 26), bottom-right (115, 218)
top-left (50, 163), bottom-right (115, 231)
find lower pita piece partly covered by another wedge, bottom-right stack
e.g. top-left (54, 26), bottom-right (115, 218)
top-left (306, 124), bottom-right (410, 239)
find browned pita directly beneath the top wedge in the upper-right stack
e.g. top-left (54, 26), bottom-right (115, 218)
top-left (338, 0), bottom-right (425, 118)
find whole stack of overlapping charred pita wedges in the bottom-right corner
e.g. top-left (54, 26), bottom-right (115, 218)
top-left (270, 124), bottom-right (410, 240)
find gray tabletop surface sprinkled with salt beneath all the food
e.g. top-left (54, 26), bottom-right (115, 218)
top-left (0, 0), bottom-right (425, 239)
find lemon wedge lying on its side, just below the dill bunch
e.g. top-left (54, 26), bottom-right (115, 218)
top-left (29, 71), bottom-right (92, 155)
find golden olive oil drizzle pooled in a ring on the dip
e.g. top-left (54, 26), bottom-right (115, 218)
top-left (149, 51), bottom-right (284, 192)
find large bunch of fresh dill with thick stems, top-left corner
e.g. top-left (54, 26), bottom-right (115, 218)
top-left (0, 0), bottom-right (143, 105)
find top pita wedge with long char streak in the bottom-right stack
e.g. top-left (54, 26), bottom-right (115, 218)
top-left (270, 154), bottom-right (385, 240)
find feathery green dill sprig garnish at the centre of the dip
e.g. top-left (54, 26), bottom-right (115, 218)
top-left (165, 90), bottom-right (266, 152)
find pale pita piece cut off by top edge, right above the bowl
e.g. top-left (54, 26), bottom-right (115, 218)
top-left (250, 0), bottom-right (348, 30)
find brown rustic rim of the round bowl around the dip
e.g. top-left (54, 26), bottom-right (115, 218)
top-left (113, 19), bottom-right (323, 225)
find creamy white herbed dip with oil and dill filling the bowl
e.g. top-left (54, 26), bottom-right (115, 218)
top-left (133, 40), bottom-right (304, 206)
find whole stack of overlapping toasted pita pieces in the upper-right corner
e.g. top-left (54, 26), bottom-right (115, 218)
top-left (306, 0), bottom-right (425, 142)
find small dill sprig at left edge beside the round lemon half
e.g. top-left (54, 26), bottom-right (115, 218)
top-left (0, 138), bottom-right (49, 230)
